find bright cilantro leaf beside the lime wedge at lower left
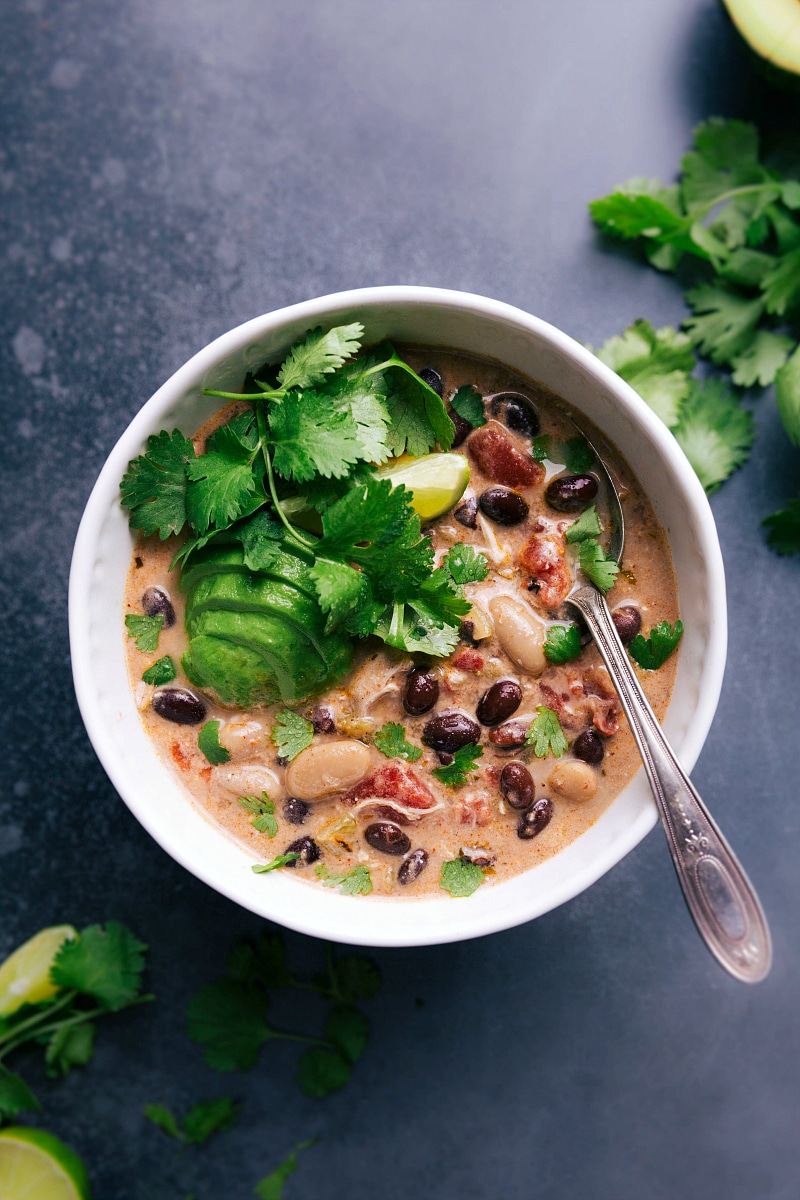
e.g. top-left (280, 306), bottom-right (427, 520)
top-left (50, 920), bottom-right (146, 1012)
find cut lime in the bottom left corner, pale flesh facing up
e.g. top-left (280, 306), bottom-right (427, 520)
top-left (0, 1126), bottom-right (91, 1200)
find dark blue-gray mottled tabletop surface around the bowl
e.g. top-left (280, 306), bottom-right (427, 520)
top-left (0, 0), bottom-right (800, 1200)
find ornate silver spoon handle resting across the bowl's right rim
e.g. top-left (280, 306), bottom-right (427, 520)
top-left (567, 587), bottom-right (772, 983)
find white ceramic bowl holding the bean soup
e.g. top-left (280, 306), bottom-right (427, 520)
top-left (70, 287), bottom-right (727, 946)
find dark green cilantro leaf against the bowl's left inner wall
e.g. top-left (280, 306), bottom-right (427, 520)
top-left (120, 430), bottom-right (194, 541)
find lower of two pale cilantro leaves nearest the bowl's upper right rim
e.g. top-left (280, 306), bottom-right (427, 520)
top-left (673, 368), bottom-right (753, 492)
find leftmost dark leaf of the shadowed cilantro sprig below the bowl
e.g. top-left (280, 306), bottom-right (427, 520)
top-left (186, 979), bottom-right (272, 1072)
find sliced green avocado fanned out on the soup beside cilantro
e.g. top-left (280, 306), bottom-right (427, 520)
top-left (181, 545), bottom-right (353, 708)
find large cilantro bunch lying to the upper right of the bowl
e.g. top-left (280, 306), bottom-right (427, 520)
top-left (589, 118), bottom-right (800, 542)
